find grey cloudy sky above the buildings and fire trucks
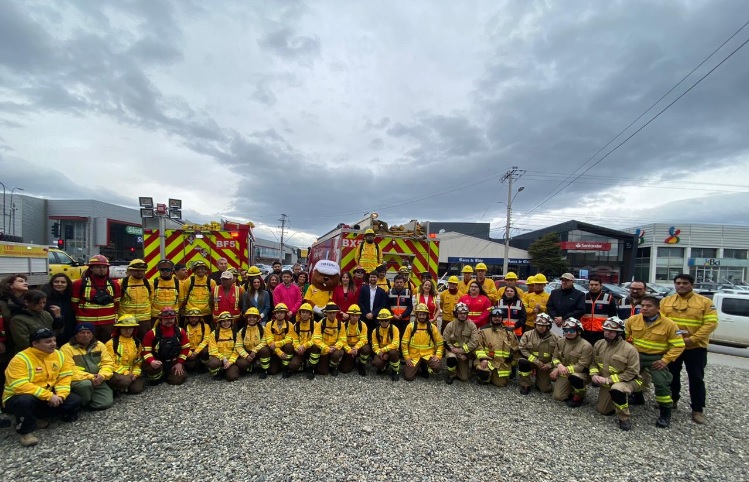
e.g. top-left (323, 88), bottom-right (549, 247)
top-left (0, 0), bottom-right (749, 246)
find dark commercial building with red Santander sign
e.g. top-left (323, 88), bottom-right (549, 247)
top-left (510, 220), bottom-right (635, 284)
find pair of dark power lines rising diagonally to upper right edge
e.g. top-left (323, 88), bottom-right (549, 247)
top-left (516, 21), bottom-right (749, 220)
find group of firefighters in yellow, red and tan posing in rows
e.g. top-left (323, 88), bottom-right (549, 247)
top-left (3, 250), bottom-right (717, 445)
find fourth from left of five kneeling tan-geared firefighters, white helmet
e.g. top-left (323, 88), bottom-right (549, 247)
top-left (550, 318), bottom-right (593, 408)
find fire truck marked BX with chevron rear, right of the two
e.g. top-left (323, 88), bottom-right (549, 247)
top-left (308, 213), bottom-right (439, 286)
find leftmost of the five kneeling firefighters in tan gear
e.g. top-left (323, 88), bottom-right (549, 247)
top-left (438, 303), bottom-right (479, 385)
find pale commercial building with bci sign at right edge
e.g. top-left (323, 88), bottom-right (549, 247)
top-left (628, 223), bottom-right (749, 283)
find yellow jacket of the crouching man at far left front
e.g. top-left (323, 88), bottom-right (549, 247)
top-left (3, 347), bottom-right (73, 406)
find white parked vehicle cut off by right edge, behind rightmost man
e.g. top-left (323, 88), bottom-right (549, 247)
top-left (710, 290), bottom-right (749, 347)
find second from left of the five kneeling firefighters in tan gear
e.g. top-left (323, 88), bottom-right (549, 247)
top-left (476, 307), bottom-right (518, 387)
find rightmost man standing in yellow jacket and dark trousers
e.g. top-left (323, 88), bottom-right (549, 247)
top-left (661, 273), bottom-right (718, 424)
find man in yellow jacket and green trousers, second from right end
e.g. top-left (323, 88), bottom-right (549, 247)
top-left (624, 296), bottom-right (684, 428)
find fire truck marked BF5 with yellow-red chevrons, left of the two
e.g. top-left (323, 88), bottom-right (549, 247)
top-left (143, 220), bottom-right (255, 279)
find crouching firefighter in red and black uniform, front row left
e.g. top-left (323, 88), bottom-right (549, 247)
top-left (143, 306), bottom-right (190, 385)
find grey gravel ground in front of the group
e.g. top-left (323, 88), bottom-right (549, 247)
top-left (0, 366), bottom-right (749, 482)
